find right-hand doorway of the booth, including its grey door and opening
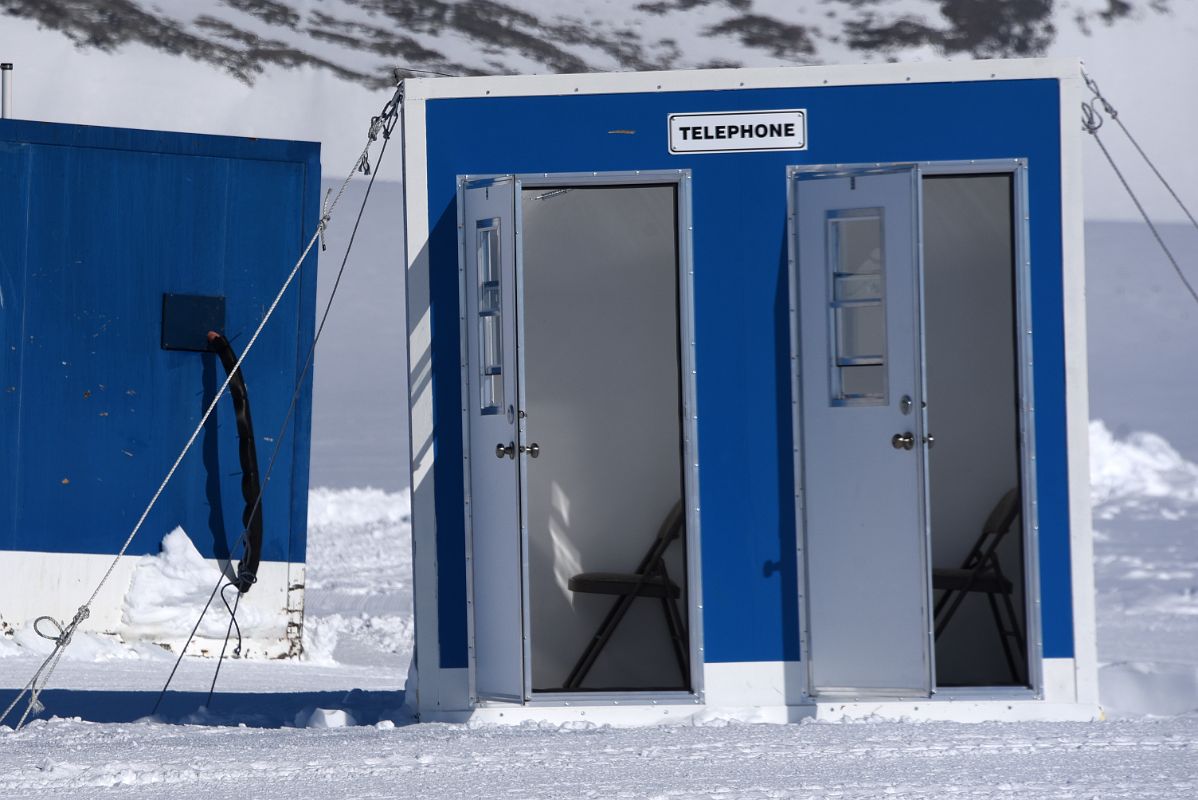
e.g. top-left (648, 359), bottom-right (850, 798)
top-left (791, 162), bottom-right (1035, 697)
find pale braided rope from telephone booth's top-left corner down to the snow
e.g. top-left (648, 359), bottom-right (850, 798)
top-left (0, 76), bottom-right (403, 731)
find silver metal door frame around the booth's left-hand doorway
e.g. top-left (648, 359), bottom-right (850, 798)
top-left (458, 169), bottom-right (704, 707)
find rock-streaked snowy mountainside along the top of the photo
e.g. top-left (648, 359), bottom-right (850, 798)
top-left (0, 0), bottom-right (1169, 87)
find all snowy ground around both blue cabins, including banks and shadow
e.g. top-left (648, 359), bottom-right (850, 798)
top-left (0, 422), bottom-right (1198, 800)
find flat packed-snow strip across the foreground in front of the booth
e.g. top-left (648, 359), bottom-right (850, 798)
top-left (0, 720), bottom-right (1198, 800)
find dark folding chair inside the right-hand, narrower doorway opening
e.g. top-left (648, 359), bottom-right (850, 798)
top-left (932, 489), bottom-right (1028, 684)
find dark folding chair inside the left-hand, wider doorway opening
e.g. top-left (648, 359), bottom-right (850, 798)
top-left (564, 501), bottom-right (690, 689)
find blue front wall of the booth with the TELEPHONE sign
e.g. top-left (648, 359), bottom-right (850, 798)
top-left (426, 80), bottom-right (1073, 668)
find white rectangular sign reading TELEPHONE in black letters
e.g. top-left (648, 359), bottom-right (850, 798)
top-left (670, 108), bottom-right (807, 153)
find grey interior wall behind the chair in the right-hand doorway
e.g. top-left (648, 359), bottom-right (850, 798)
top-left (924, 176), bottom-right (1023, 685)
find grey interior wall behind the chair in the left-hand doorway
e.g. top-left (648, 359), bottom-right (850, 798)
top-left (522, 187), bottom-right (685, 690)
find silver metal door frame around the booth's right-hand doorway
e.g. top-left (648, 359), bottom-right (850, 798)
top-left (786, 158), bottom-right (1043, 703)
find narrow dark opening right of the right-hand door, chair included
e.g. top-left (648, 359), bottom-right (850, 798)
top-left (922, 172), bottom-right (1029, 687)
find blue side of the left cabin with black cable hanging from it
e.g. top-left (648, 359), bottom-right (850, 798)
top-left (0, 121), bottom-right (320, 562)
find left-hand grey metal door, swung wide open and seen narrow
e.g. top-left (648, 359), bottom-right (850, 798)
top-left (458, 176), bottom-right (525, 701)
